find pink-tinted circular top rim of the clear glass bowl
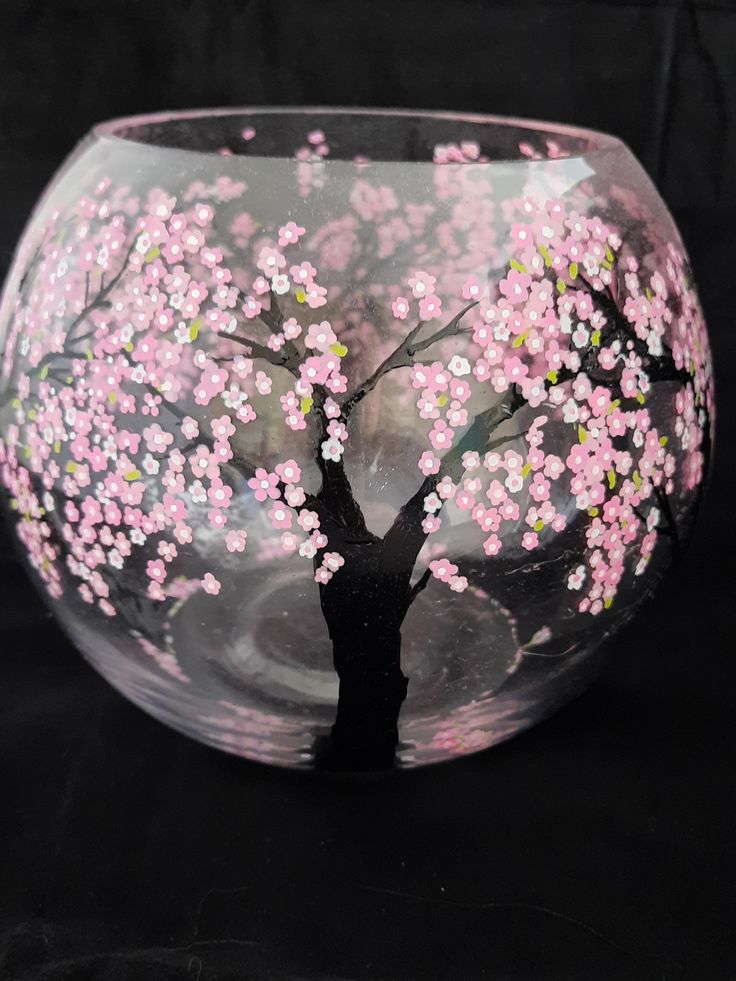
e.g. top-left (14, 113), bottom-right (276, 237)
top-left (92, 105), bottom-right (625, 166)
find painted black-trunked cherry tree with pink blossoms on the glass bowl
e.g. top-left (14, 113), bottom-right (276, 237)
top-left (0, 133), bottom-right (712, 766)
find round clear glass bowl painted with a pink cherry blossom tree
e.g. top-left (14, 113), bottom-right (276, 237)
top-left (0, 109), bottom-right (713, 768)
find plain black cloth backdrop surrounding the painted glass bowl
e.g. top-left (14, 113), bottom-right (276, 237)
top-left (0, 0), bottom-right (736, 981)
